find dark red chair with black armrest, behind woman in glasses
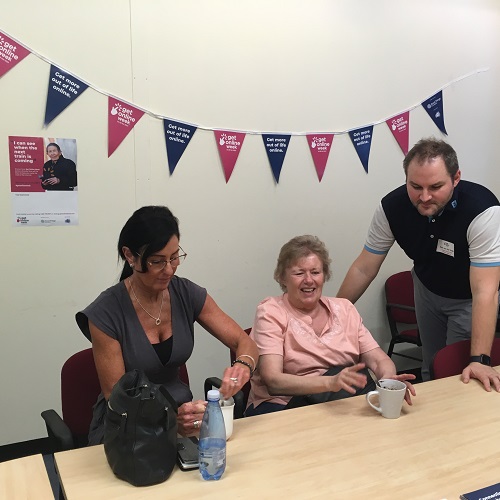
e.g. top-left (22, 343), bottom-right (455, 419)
top-left (42, 348), bottom-right (189, 451)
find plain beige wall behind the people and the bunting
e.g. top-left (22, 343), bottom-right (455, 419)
top-left (0, 0), bottom-right (500, 445)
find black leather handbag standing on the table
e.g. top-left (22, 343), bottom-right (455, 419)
top-left (104, 370), bottom-right (177, 486)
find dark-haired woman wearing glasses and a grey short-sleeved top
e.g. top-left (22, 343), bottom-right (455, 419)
top-left (76, 206), bottom-right (258, 444)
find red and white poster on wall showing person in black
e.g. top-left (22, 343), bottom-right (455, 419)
top-left (9, 136), bottom-right (78, 226)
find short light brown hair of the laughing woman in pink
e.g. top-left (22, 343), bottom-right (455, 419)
top-left (274, 234), bottom-right (332, 292)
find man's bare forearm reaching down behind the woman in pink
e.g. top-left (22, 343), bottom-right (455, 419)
top-left (337, 248), bottom-right (387, 304)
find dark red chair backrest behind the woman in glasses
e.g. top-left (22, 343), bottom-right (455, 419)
top-left (61, 348), bottom-right (189, 437)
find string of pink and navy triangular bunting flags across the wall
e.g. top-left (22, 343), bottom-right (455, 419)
top-left (0, 26), bottom-right (489, 183)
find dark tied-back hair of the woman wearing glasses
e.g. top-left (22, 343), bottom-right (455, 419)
top-left (118, 205), bottom-right (180, 281)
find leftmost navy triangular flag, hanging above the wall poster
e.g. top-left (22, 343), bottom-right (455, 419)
top-left (44, 64), bottom-right (88, 126)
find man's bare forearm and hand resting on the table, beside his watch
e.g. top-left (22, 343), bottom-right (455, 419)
top-left (462, 266), bottom-right (500, 392)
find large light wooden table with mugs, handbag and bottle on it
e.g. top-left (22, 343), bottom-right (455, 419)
top-left (56, 376), bottom-right (500, 500)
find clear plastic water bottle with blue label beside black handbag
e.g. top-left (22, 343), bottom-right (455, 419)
top-left (198, 389), bottom-right (226, 481)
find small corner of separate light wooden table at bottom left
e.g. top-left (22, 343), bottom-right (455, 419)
top-left (0, 455), bottom-right (54, 500)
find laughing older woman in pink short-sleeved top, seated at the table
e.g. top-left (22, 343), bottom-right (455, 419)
top-left (246, 235), bottom-right (415, 415)
